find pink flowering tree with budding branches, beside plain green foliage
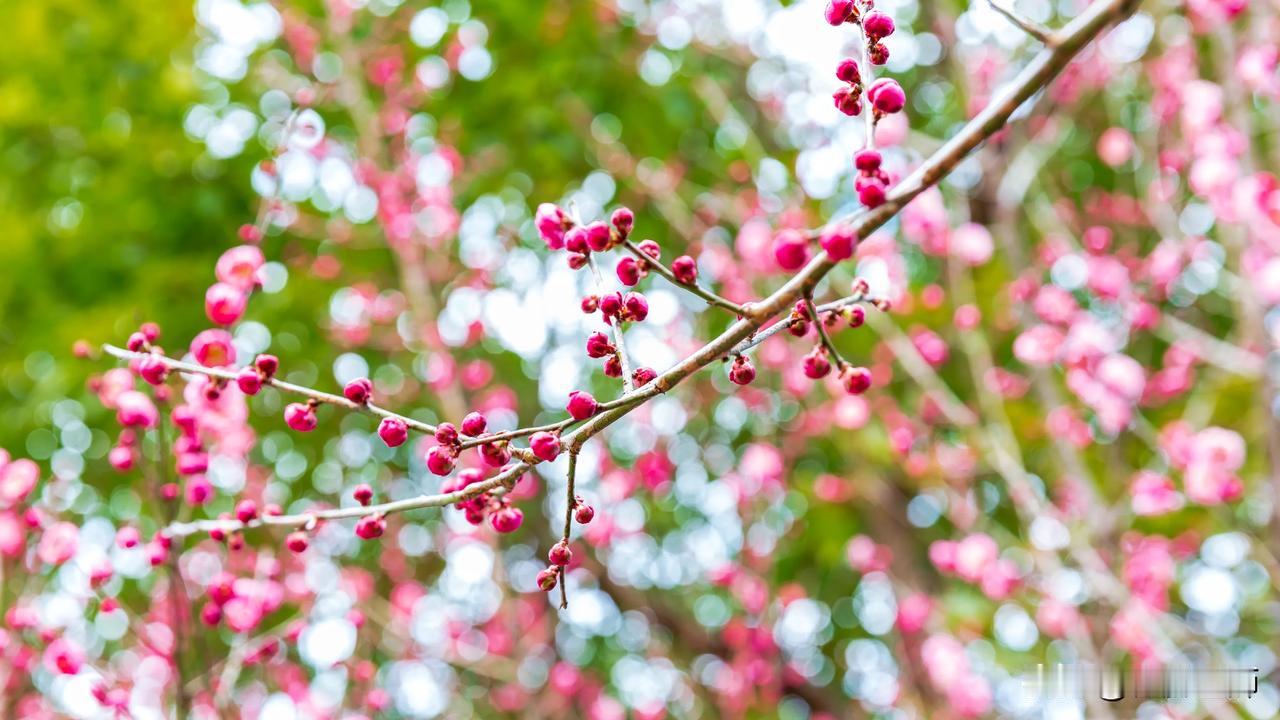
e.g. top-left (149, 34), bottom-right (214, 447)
top-left (0, 0), bottom-right (1280, 720)
